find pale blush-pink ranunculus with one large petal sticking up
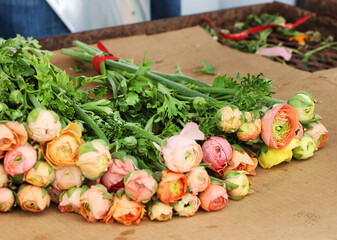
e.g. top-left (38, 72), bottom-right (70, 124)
top-left (160, 122), bottom-right (205, 172)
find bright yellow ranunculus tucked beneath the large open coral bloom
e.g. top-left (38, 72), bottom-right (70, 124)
top-left (258, 138), bottom-right (300, 168)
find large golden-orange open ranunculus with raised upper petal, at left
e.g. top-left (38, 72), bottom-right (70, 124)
top-left (41, 123), bottom-right (84, 169)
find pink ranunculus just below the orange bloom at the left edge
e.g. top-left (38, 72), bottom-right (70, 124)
top-left (4, 143), bottom-right (37, 176)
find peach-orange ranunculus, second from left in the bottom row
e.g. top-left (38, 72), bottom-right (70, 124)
top-left (18, 184), bottom-right (50, 212)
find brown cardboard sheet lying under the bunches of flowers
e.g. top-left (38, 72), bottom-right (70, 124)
top-left (0, 27), bottom-right (337, 240)
